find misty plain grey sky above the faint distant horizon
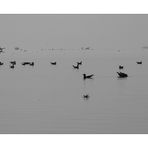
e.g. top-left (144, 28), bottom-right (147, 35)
top-left (0, 15), bottom-right (148, 50)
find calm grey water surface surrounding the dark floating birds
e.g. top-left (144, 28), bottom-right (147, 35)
top-left (0, 49), bottom-right (148, 133)
